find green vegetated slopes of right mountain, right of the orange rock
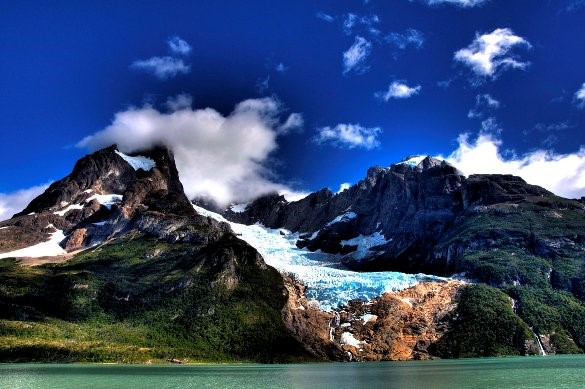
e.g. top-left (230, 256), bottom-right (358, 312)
top-left (437, 196), bottom-right (585, 356)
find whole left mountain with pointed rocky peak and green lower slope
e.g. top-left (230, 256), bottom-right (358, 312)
top-left (0, 146), bottom-right (313, 362)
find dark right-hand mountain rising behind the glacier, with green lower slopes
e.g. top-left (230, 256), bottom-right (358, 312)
top-left (223, 157), bottom-right (585, 355)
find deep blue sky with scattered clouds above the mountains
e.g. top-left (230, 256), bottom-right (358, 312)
top-left (0, 0), bottom-right (585, 215)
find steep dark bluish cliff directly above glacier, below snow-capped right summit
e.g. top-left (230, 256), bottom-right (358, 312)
top-left (225, 157), bottom-right (465, 270)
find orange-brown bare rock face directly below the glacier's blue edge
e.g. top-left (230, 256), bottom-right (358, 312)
top-left (283, 280), bottom-right (465, 361)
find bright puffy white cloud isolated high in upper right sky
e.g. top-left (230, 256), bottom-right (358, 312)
top-left (454, 28), bottom-right (531, 77)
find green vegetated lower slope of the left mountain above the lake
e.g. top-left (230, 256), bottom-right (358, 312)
top-left (0, 236), bottom-right (309, 363)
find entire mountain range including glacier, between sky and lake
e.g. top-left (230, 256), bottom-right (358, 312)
top-left (0, 146), bottom-right (585, 362)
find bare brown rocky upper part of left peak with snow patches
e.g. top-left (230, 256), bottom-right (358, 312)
top-left (0, 146), bottom-right (230, 253)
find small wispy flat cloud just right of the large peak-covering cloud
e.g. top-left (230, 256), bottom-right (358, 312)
top-left (313, 123), bottom-right (382, 150)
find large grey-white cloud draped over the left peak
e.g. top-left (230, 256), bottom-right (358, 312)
top-left (78, 98), bottom-right (306, 205)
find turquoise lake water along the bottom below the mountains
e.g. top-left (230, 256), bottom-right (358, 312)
top-left (0, 355), bottom-right (585, 389)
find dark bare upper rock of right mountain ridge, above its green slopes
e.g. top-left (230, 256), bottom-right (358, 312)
top-left (224, 157), bottom-right (585, 275)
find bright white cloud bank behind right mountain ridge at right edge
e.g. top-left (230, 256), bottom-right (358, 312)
top-left (446, 133), bottom-right (585, 198)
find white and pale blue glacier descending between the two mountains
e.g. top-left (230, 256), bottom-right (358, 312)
top-left (193, 205), bottom-right (447, 311)
